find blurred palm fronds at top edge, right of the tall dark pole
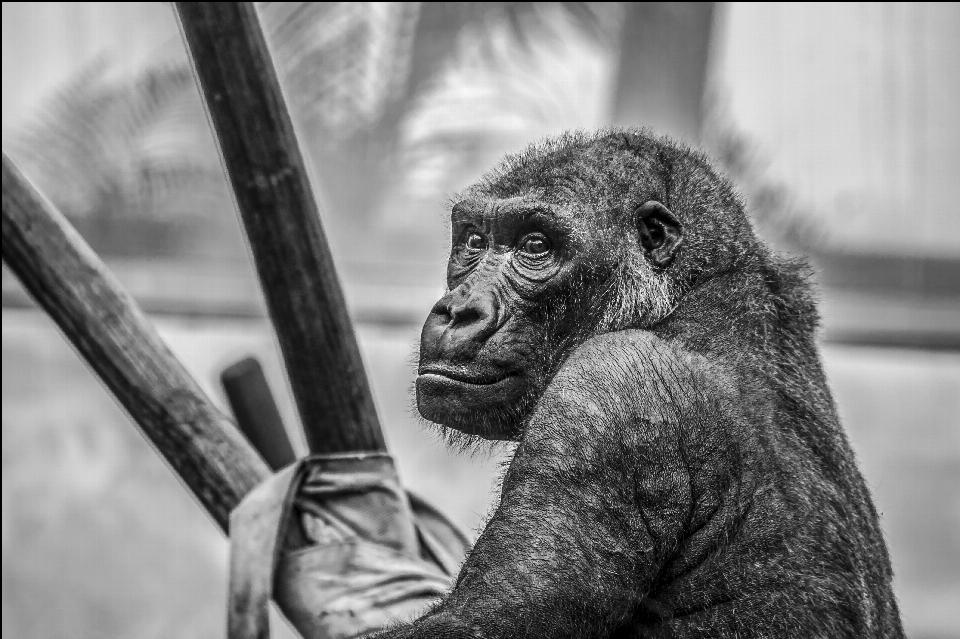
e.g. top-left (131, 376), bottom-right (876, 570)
top-left (258, 2), bottom-right (609, 138)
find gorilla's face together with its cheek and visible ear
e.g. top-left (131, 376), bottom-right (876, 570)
top-left (416, 172), bottom-right (680, 439)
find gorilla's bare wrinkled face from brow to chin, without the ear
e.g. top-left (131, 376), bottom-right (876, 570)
top-left (417, 197), bottom-right (589, 439)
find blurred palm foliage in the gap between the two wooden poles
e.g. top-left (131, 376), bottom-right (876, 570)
top-left (4, 58), bottom-right (237, 257)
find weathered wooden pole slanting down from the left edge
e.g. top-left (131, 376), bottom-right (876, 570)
top-left (3, 154), bottom-right (269, 531)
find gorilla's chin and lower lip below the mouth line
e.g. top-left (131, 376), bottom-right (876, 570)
top-left (416, 373), bottom-right (526, 440)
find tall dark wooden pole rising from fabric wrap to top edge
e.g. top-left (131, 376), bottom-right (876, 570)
top-left (176, 2), bottom-right (386, 453)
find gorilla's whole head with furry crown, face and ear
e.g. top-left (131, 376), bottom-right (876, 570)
top-left (416, 131), bottom-right (755, 439)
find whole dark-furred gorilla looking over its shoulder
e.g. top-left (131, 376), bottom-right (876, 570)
top-left (378, 129), bottom-right (903, 639)
